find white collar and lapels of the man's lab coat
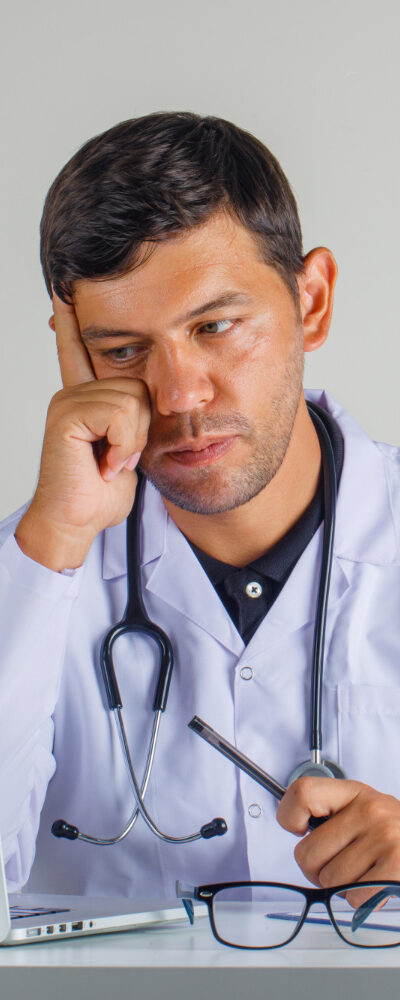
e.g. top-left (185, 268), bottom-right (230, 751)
top-left (103, 392), bottom-right (398, 655)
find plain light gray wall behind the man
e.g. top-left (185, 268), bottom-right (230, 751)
top-left (0, 0), bottom-right (400, 517)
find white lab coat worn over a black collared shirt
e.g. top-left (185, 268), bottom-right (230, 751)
top-left (0, 393), bottom-right (400, 897)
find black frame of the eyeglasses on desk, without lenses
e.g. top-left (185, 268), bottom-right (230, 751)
top-left (175, 879), bottom-right (400, 951)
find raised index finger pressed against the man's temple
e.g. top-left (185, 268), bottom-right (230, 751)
top-left (49, 291), bottom-right (95, 388)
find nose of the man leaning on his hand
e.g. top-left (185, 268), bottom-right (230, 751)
top-left (146, 347), bottom-right (214, 416)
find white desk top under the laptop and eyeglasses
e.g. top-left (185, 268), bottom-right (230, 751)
top-left (0, 917), bottom-right (400, 1000)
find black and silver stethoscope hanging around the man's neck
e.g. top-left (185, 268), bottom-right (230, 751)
top-left (51, 402), bottom-right (345, 847)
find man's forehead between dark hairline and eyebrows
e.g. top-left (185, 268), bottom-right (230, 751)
top-left (74, 212), bottom-right (283, 325)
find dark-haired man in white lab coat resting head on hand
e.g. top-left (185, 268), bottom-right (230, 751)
top-left (0, 113), bottom-right (400, 897)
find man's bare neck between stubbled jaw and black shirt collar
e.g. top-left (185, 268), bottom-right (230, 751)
top-left (164, 396), bottom-right (321, 566)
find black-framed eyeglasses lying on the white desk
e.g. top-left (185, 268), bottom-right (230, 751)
top-left (176, 881), bottom-right (400, 948)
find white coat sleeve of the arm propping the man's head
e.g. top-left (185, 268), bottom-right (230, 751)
top-left (0, 508), bottom-right (85, 891)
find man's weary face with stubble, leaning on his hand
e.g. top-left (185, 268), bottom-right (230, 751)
top-left (74, 213), bottom-right (303, 514)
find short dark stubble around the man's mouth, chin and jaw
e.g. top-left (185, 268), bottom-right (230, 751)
top-left (139, 336), bottom-right (304, 514)
